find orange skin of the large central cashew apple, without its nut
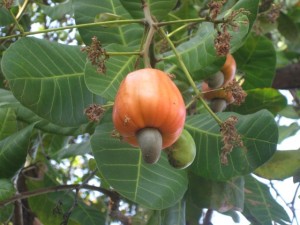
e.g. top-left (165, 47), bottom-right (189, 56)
top-left (112, 68), bottom-right (186, 148)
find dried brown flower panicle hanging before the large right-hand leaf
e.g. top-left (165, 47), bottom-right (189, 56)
top-left (220, 116), bottom-right (244, 165)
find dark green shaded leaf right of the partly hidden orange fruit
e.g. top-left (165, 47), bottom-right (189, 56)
top-left (234, 35), bottom-right (276, 90)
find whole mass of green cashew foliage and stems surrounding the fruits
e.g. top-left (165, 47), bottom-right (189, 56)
top-left (0, 0), bottom-right (300, 225)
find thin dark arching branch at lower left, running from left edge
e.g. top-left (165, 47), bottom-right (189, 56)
top-left (0, 184), bottom-right (115, 209)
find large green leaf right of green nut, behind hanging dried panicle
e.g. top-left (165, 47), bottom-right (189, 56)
top-left (185, 110), bottom-right (278, 180)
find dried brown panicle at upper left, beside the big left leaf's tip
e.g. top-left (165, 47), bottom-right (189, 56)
top-left (81, 36), bottom-right (109, 73)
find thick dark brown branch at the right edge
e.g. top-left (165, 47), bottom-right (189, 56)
top-left (272, 63), bottom-right (300, 90)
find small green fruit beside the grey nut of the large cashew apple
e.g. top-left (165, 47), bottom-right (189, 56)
top-left (164, 130), bottom-right (196, 169)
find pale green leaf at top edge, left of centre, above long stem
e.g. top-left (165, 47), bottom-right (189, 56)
top-left (39, 0), bottom-right (73, 20)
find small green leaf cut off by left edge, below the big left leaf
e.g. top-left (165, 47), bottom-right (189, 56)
top-left (0, 108), bottom-right (17, 140)
